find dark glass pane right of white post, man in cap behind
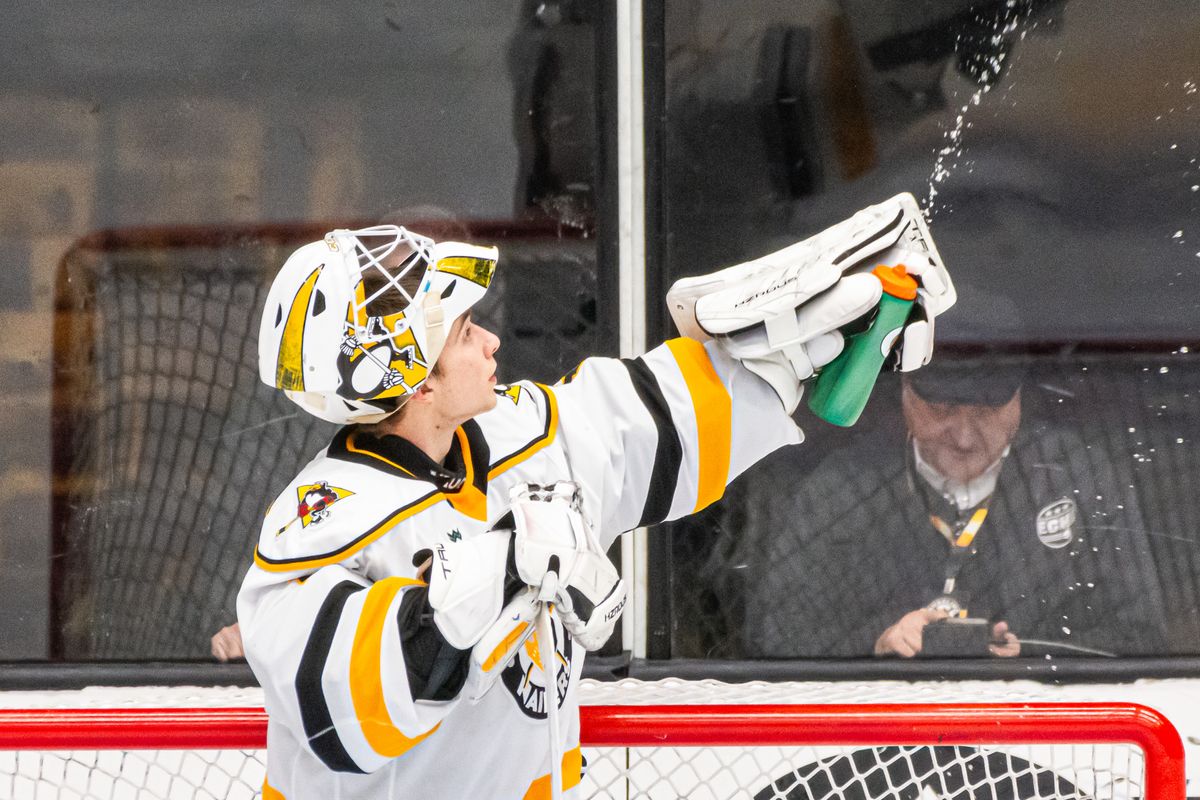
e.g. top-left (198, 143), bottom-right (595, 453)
top-left (652, 0), bottom-right (1200, 657)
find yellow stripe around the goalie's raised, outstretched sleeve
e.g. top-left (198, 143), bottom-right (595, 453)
top-left (666, 338), bottom-right (733, 511)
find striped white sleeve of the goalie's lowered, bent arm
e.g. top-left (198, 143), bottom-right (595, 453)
top-left (238, 565), bottom-right (458, 772)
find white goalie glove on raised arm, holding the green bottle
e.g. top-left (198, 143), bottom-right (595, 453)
top-left (667, 193), bottom-right (955, 414)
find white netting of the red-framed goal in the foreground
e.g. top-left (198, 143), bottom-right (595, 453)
top-left (0, 680), bottom-right (1161, 800)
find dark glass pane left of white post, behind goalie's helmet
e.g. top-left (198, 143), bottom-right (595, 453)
top-left (0, 0), bottom-right (616, 658)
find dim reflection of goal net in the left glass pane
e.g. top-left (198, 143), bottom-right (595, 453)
top-left (50, 221), bottom-right (600, 661)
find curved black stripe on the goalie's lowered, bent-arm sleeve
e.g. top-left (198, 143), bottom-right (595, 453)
top-left (296, 581), bottom-right (362, 774)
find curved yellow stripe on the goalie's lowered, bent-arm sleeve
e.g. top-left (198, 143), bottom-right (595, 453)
top-left (350, 577), bottom-right (438, 758)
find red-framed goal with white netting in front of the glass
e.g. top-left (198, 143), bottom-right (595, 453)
top-left (0, 680), bottom-right (1184, 800)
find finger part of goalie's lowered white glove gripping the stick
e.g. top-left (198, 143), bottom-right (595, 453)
top-left (497, 481), bottom-right (625, 650)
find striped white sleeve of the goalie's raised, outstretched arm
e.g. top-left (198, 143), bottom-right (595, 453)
top-left (553, 338), bottom-right (803, 546)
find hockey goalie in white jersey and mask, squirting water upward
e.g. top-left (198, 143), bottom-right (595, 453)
top-left (238, 194), bottom-right (954, 800)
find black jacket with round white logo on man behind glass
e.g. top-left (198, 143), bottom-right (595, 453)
top-left (698, 417), bottom-right (1165, 657)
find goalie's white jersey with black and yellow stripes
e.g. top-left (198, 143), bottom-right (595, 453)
top-left (238, 339), bottom-right (802, 800)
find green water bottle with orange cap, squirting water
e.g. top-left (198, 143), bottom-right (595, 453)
top-left (809, 264), bottom-right (917, 428)
